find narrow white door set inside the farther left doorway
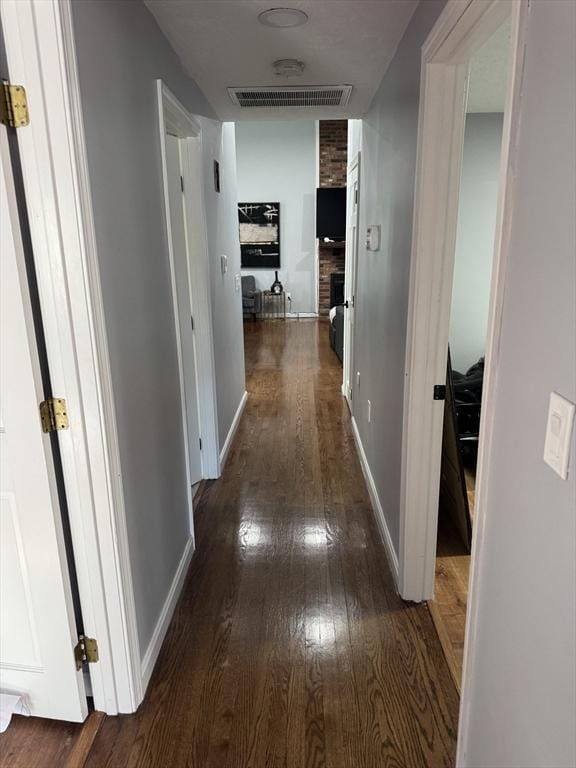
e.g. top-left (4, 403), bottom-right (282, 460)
top-left (166, 135), bottom-right (202, 485)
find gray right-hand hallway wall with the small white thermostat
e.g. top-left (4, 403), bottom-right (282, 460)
top-left (352, 0), bottom-right (444, 550)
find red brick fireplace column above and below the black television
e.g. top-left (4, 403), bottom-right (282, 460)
top-left (318, 120), bottom-right (348, 315)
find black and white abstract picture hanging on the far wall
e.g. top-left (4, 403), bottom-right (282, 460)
top-left (238, 203), bottom-right (280, 269)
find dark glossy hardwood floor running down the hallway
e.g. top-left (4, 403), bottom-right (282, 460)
top-left (0, 321), bottom-right (458, 768)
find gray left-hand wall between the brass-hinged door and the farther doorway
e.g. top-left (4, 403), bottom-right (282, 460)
top-left (73, 0), bottom-right (217, 653)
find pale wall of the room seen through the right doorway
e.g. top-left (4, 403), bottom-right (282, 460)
top-left (450, 113), bottom-right (503, 373)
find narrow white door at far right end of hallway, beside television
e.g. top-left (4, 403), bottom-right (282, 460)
top-left (343, 157), bottom-right (360, 410)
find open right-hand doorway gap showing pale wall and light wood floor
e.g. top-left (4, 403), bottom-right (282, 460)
top-left (429, 19), bottom-right (511, 690)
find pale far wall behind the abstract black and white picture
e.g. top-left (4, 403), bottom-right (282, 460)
top-left (236, 120), bottom-right (317, 312)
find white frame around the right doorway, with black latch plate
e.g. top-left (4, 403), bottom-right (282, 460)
top-left (398, 0), bottom-right (528, 614)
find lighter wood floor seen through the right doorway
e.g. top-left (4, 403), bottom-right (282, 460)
top-left (428, 469), bottom-right (476, 691)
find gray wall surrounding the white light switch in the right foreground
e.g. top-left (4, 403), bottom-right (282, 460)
top-left (461, 0), bottom-right (576, 768)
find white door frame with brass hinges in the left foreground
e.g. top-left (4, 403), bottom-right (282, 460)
top-left (1, 0), bottom-right (144, 715)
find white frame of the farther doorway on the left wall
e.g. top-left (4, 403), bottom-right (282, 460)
top-left (156, 80), bottom-right (220, 486)
